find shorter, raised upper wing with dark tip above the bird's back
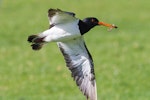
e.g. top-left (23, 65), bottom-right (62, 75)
top-left (48, 9), bottom-right (77, 26)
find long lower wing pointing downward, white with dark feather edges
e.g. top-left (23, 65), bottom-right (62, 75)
top-left (57, 37), bottom-right (97, 100)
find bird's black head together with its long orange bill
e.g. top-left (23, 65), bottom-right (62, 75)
top-left (83, 17), bottom-right (117, 29)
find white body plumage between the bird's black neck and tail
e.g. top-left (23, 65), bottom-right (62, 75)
top-left (38, 20), bottom-right (81, 42)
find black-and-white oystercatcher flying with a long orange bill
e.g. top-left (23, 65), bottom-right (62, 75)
top-left (27, 8), bottom-right (117, 100)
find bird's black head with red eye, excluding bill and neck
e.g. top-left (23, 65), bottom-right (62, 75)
top-left (82, 17), bottom-right (99, 28)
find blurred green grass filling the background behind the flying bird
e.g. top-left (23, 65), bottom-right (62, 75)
top-left (0, 0), bottom-right (150, 100)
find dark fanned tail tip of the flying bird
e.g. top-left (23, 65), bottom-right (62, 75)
top-left (28, 35), bottom-right (44, 50)
